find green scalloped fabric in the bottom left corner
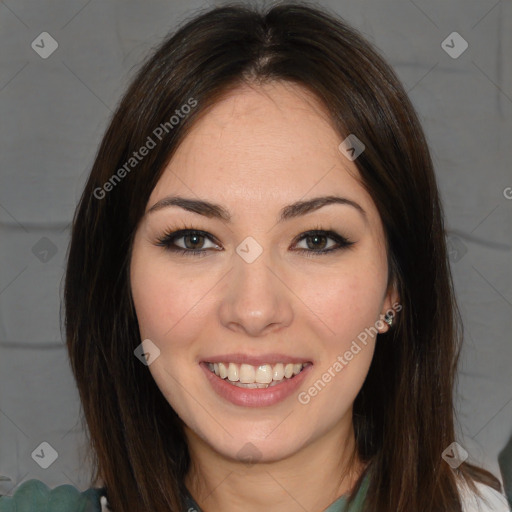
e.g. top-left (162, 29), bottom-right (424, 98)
top-left (0, 479), bottom-right (109, 512)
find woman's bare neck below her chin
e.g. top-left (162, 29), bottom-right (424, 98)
top-left (185, 421), bottom-right (364, 512)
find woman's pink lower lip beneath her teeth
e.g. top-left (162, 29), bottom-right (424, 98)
top-left (199, 363), bottom-right (313, 407)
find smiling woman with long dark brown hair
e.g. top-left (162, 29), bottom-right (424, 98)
top-left (0, 4), bottom-right (508, 512)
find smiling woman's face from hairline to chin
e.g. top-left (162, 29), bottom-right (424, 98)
top-left (131, 83), bottom-right (397, 462)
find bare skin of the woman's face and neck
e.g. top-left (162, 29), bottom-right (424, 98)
top-left (130, 82), bottom-right (398, 512)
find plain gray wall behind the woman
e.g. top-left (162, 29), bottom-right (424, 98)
top-left (0, 0), bottom-right (512, 494)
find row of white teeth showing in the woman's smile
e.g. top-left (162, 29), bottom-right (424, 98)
top-left (206, 362), bottom-right (311, 389)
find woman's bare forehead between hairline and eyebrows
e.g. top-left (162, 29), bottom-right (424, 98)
top-left (148, 82), bottom-right (372, 220)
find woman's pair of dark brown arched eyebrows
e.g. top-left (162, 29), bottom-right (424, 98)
top-left (147, 196), bottom-right (367, 223)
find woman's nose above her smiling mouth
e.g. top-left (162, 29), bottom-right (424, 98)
top-left (219, 251), bottom-right (294, 336)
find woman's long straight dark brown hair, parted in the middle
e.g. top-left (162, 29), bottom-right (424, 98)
top-left (64, 3), bottom-right (501, 512)
